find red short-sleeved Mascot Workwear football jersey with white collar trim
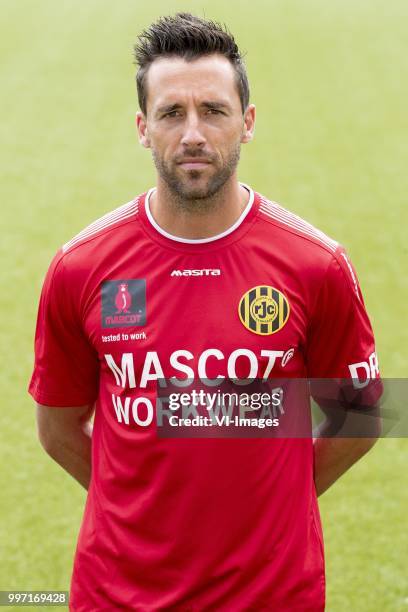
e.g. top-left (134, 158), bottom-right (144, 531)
top-left (29, 186), bottom-right (378, 612)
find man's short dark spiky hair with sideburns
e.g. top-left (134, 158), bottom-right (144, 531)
top-left (133, 13), bottom-right (249, 115)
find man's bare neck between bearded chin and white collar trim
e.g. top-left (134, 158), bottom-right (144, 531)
top-left (149, 180), bottom-right (249, 240)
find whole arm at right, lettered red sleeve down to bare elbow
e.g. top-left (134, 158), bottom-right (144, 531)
top-left (306, 245), bottom-right (381, 495)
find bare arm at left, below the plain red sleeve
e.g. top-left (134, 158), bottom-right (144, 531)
top-left (37, 404), bottom-right (95, 490)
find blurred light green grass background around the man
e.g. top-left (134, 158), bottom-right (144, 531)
top-left (0, 0), bottom-right (408, 612)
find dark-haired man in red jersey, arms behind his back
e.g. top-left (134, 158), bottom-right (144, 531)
top-left (30, 13), bottom-right (378, 612)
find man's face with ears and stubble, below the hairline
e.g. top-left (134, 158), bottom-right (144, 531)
top-left (137, 54), bottom-right (255, 200)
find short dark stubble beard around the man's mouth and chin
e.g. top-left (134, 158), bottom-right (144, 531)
top-left (152, 143), bottom-right (241, 213)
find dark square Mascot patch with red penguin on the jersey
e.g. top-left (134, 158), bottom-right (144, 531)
top-left (101, 279), bottom-right (146, 327)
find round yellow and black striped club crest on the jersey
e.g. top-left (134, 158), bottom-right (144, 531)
top-left (238, 285), bottom-right (290, 336)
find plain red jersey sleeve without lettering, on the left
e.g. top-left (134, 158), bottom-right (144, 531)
top-left (28, 253), bottom-right (99, 407)
